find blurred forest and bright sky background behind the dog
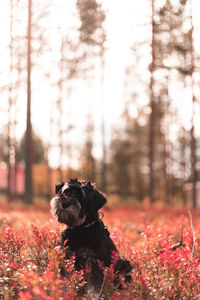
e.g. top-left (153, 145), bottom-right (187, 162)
top-left (0, 0), bottom-right (200, 208)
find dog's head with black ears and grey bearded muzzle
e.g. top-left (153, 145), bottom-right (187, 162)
top-left (51, 179), bottom-right (106, 227)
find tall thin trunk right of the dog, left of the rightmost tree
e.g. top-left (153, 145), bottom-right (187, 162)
top-left (149, 0), bottom-right (155, 203)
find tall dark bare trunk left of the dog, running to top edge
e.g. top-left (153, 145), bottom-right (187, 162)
top-left (25, 0), bottom-right (32, 204)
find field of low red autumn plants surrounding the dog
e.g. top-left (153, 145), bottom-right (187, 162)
top-left (0, 204), bottom-right (200, 300)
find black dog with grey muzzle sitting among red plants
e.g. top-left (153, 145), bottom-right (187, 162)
top-left (51, 179), bottom-right (132, 299)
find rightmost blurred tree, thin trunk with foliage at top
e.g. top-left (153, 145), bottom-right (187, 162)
top-left (164, 0), bottom-right (198, 208)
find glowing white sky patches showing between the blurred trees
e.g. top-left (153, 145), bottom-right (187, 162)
top-left (0, 0), bottom-right (200, 168)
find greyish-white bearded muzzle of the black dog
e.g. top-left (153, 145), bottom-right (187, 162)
top-left (50, 197), bottom-right (86, 227)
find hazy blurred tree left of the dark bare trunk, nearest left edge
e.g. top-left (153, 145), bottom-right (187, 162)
top-left (4, 0), bottom-right (29, 200)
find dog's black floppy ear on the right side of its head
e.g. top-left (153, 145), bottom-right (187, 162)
top-left (85, 182), bottom-right (106, 211)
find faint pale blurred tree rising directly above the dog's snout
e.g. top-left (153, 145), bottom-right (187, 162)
top-left (52, 31), bottom-right (83, 181)
